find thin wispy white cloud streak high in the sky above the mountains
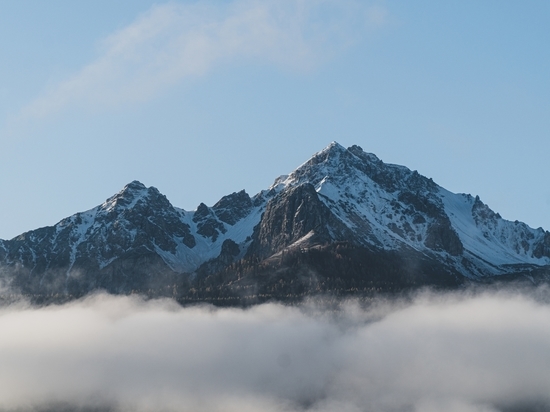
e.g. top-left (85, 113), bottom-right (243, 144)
top-left (23, 0), bottom-right (385, 117)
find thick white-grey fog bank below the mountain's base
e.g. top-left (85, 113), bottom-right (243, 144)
top-left (0, 292), bottom-right (550, 412)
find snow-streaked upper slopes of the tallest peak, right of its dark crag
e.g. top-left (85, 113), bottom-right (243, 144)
top-left (260, 142), bottom-right (550, 274)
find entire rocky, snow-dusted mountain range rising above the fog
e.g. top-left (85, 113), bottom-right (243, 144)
top-left (0, 142), bottom-right (550, 304)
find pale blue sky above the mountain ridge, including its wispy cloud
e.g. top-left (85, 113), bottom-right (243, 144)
top-left (0, 0), bottom-right (550, 239)
